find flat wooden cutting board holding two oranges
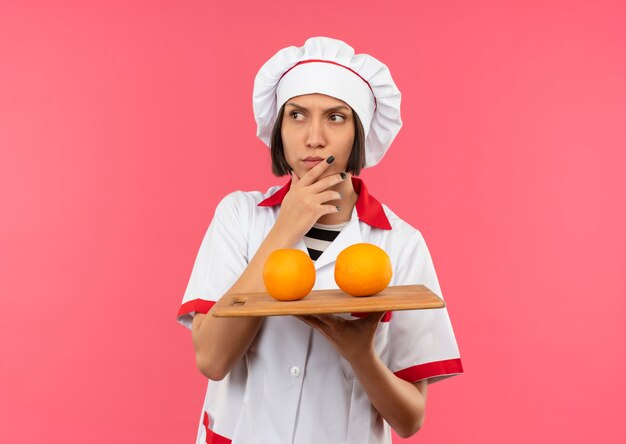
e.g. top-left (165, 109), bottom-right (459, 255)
top-left (211, 285), bottom-right (446, 317)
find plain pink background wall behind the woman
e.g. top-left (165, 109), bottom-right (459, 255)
top-left (0, 0), bottom-right (626, 444)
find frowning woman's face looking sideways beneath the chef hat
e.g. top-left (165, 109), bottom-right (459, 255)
top-left (281, 94), bottom-right (355, 177)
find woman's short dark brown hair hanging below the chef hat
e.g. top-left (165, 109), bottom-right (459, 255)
top-left (270, 105), bottom-right (365, 177)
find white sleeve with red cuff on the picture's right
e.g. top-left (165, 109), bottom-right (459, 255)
top-left (389, 230), bottom-right (463, 383)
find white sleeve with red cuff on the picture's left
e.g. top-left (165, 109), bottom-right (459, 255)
top-left (177, 192), bottom-right (248, 328)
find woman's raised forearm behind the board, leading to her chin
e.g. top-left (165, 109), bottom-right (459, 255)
top-left (192, 230), bottom-right (296, 380)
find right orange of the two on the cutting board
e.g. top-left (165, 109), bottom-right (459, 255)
top-left (335, 243), bottom-right (392, 296)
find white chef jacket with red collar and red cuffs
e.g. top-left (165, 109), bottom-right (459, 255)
top-left (178, 177), bottom-right (463, 444)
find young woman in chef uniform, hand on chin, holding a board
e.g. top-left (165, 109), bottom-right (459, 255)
top-left (178, 37), bottom-right (463, 444)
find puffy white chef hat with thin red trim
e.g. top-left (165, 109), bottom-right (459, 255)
top-left (252, 37), bottom-right (402, 167)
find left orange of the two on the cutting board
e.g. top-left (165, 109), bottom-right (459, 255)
top-left (263, 248), bottom-right (315, 301)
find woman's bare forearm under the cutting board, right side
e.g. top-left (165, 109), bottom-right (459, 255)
top-left (350, 350), bottom-right (427, 438)
